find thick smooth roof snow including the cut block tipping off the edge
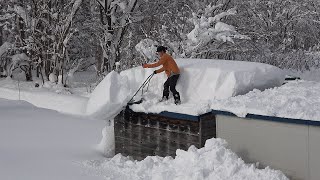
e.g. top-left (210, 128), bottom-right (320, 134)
top-left (87, 59), bottom-right (285, 117)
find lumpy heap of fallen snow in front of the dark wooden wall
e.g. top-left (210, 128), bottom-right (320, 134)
top-left (83, 139), bottom-right (288, 180)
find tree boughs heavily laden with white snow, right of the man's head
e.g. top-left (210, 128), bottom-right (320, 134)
top-left (184, 4), bottom-right (250, 57)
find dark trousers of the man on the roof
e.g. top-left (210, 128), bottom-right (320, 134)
top-left (163, 74), bottom-right (180, 100)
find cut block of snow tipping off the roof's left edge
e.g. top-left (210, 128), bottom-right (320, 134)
top-left (86, 71), bottom-right (130, 118)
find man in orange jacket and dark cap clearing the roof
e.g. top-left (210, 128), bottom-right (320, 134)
top-left (143, 46), bottom-right (181, 105)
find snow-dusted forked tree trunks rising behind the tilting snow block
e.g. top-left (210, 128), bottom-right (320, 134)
top-left (96, 0), bottom-right (138, 73)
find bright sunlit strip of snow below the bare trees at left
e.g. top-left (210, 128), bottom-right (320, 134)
top-left (0, 79), bottom-right (88, 115)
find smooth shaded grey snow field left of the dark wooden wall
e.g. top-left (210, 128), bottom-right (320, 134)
top-left (0, 99), bottom-right (106, 180)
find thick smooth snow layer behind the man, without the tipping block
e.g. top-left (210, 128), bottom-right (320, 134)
top-left (106, 59), bottom-right (284, 115)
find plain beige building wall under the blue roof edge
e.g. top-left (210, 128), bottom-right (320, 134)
top-left (216, 115), bottom-right (320, 180)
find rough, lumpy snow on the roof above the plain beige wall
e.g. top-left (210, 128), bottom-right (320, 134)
top-left (211, 81), bottom-right (320, 121)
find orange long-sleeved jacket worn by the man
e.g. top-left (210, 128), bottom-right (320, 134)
top-left (144, 53), bottom-right (180, 77)
